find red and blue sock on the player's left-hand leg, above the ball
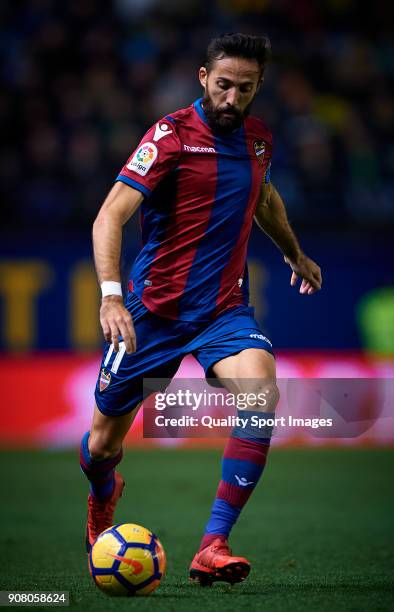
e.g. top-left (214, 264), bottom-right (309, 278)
top-left (79, 431), bottom-right (123, 500)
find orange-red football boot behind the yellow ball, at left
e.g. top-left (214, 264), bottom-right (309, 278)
top-left (86, 472), bottom-right (125, 552)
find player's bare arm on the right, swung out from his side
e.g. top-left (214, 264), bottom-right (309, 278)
top-left (255, 183), bottom-right (322, 295)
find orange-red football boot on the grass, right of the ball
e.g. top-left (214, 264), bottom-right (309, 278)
top-left (190, 537), bottom-right (250, 586)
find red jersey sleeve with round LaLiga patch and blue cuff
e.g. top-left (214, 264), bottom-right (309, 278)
top-left (116, 118), bottom-right (181, 197)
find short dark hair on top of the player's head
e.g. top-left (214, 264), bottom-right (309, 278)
top-left (205, 32), bottom-right (271, 74)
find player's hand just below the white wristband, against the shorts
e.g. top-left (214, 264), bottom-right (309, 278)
top-left (100, 295), bottom-right (137, 354)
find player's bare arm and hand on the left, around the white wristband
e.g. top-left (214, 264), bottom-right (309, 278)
top-left (93, 182), bottom-right (143, 353)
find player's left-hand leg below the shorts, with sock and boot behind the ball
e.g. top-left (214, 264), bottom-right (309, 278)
top-left (80, 406), bottom-right (139, 552)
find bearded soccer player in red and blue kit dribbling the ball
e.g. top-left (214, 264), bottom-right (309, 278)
top-left (80, 34), bottom-right (321, 584)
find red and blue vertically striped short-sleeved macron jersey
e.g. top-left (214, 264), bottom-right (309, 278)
top-left (117, 99), bottom-right (272, 321)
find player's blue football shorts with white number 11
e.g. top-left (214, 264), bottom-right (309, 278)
top-left (95, 292), bottom-right (272, 416)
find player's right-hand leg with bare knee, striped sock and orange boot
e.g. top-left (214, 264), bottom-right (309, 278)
top-left (190, 348), bottom-right (279, 586)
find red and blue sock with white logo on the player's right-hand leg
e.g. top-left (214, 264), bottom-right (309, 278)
top-left (200, 410), bottom-right (274, 550)
